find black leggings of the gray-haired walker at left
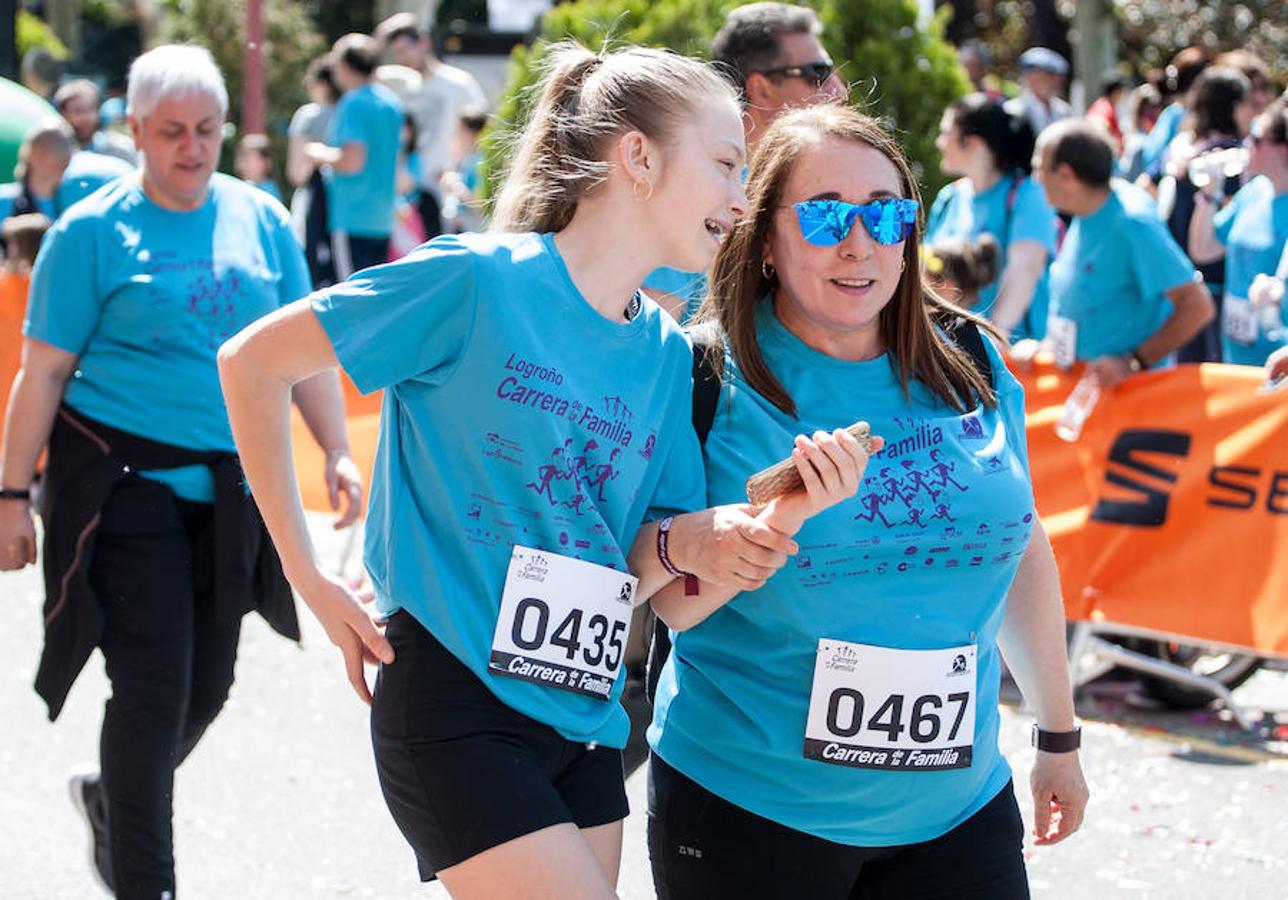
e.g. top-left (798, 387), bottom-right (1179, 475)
top-left (90, 478), bottom-right (241, 899)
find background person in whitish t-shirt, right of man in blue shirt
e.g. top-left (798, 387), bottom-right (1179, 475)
top-left (375, 13), bottom-right (487, 238)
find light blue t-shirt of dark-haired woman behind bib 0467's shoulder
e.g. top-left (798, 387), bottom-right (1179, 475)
top-left (925, 175), bottom-right (1056, 341)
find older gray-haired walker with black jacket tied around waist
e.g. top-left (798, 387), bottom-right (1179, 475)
top-left (0, 46), bottom-right (361, 897)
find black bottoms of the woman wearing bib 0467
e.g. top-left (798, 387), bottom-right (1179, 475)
top-left (648, 756), bottom-right (1029, 900)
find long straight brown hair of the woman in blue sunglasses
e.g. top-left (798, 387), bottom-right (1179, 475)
top-left (697, 104), bottom-right (998, 417)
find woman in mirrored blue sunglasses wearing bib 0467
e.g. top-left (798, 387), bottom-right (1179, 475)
top-left (649, 107), bottom-right (1087, 900)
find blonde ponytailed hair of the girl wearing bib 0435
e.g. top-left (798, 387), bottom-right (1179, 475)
top-left (492, 41), bottom-right (737, 232)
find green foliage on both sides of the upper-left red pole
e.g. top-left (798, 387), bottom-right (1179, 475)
top-left (165, 0), bottom-right (326, 173)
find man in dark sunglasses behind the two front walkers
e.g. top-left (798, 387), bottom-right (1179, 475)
top-left (644, 3), bottom-right (848, 322)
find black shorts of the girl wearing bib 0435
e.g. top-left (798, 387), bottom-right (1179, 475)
top-left (371, 612), bottom-right (630, 881)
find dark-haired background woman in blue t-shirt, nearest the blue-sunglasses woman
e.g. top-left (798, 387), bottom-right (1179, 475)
top-left (926, 94), bottom-right (1057, 341)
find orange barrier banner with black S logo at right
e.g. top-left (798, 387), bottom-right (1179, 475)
top-left (1016, 363), bottom-right (1288, 655)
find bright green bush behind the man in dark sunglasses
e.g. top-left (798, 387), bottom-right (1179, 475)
top-left (486, 0), bottom-right (970, 197)
